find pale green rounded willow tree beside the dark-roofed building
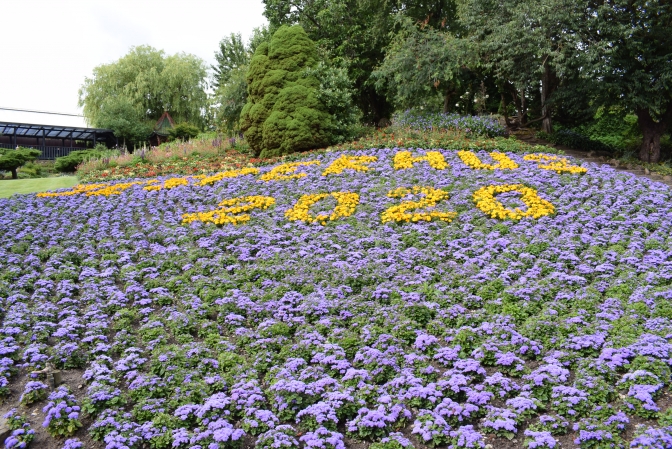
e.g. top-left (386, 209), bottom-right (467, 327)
top-left (79, 46), bottom-right (207, 130)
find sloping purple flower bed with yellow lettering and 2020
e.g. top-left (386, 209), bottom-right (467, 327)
top-left (0, 149), bottom-right (672, 449)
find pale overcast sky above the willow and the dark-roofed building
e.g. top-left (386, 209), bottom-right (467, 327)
top-left (0, 0), bottom-right (267, 126)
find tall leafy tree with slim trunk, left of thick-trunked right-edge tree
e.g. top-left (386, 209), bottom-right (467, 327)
top-left (460, 0), bottom-right (587, 133)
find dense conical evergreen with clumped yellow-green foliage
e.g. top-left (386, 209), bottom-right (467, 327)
top-left (241, 25), bottom-right (331, 157)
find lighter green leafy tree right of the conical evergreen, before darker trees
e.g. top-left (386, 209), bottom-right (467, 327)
top-left (373, 15), bottom-right (466, 112)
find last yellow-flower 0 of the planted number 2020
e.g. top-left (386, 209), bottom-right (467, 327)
top-left (473, 184), bottom-right (555, 220)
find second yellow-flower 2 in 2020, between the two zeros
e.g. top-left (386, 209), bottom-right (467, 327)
top-left (381, 186), bottom-right (457, 223)
